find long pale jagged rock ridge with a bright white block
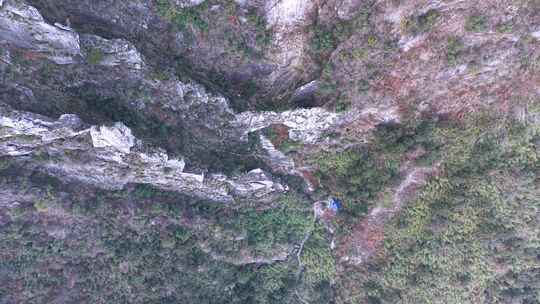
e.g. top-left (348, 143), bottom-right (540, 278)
top-left (0, 106), bottom-right (286, 202)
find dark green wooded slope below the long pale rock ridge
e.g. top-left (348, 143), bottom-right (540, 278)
top-left (0, 170), bottom-right (334, 303)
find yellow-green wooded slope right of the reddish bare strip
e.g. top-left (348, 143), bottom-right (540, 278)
top-left (336, 108), bottom-right (540, 303)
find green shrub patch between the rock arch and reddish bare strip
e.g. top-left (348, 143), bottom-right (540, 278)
top-left (315, 119), bottom-right (441, 221)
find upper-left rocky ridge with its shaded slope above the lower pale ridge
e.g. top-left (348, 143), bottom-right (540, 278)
top-left (0, 1), bottom-right (244, 171)
